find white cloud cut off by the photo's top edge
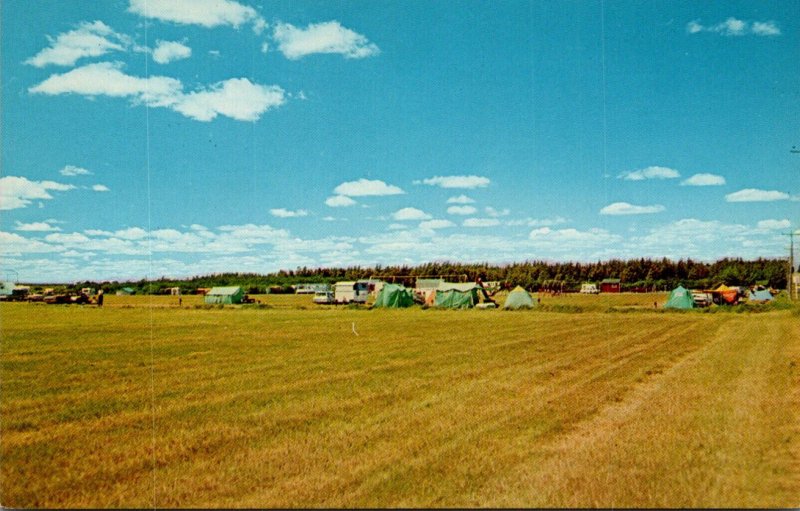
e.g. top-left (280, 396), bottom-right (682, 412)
top-left (128, 0), bottom-right (266, 32)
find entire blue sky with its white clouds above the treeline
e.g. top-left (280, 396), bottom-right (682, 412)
top-left (0, 0), bottom-right (800, 282)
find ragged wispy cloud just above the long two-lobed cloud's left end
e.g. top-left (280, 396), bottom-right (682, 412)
top-left (25, 21), bottom-right (130, 67)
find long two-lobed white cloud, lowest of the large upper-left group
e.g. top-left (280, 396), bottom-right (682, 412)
top-left (28, 62), bottom-right (286, 121)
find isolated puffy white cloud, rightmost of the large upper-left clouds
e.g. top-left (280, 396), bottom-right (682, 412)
top-left (272, 21), bottom-right (380, 60)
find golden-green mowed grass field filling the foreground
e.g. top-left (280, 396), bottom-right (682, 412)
top-left (0, 295), bottom-right (800, 507)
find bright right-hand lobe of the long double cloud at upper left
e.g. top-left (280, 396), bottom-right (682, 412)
top-left (172, 78), bottom-right (286, 121)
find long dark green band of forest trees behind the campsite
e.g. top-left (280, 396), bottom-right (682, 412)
top-left (65, 259), bottom-right (789, 294)
